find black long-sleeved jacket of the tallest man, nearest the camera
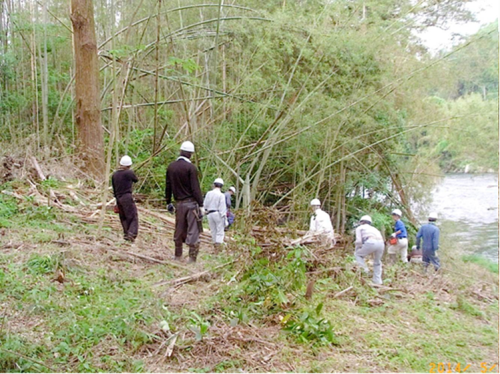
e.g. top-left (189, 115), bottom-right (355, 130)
top-left (165, 158), bottom-right (203, 206)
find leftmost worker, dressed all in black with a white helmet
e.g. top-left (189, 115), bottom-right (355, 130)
top-left (111, 156), bottom-right (139, 242)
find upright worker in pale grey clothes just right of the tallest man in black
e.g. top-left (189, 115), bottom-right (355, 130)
top-left (203, 178), bottom-right (227, 253)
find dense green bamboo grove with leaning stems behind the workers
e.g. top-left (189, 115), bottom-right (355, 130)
top-left (0, 0), bottom-right (497, 230)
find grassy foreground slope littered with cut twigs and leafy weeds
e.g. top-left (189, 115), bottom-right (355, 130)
top-left (0, 180), bottom-right (498, 373)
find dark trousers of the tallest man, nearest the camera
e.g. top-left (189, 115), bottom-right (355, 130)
top-left (174, 201), bottom-right (200, 256)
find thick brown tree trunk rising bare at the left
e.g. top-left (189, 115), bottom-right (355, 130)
top-left (71, 0), bottom-right (105, 181)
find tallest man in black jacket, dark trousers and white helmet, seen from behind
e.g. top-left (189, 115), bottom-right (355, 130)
top-left (165, 141), bottom-right (204, 263)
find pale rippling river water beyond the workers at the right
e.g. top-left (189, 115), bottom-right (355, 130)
top-left (430, 174), bottom-right (498, 261)
